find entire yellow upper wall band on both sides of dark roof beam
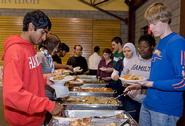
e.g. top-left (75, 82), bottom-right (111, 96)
top-left (0, 0), bottom-right (128, 11)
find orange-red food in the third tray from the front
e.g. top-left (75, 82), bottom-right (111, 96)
top-left (73, 87), bottom-right (113, 92)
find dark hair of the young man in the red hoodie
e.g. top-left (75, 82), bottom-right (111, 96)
top-left (23, 10), bottom-right (51, 31)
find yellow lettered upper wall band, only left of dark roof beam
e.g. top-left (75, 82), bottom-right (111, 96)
top-left (0, 0), bottom-right (97, 10)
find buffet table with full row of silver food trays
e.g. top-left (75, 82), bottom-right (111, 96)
top-left (49, 75), bottom-right (137, 126)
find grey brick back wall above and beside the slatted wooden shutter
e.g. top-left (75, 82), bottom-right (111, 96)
top-left (0, 9), bottom-right (128, 41)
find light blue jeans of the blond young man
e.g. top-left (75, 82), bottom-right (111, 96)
top-left (139, 105), bottom-right (179, 126)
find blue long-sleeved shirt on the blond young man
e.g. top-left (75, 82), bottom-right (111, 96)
top-left (144, 33), bottom-right (185, 117)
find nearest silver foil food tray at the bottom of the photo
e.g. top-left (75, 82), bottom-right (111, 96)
top-left (50, 110), bottom-right (129, 126)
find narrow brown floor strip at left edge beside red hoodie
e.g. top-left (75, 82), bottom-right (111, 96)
top-left (0, 84), bottom-right (8, 126)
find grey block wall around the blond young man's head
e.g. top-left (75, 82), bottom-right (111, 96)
top-left (135, 0), bottom-right (181, 43)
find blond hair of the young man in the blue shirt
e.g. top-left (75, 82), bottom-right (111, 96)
top-left (144, 3), bottom-right (172, 24)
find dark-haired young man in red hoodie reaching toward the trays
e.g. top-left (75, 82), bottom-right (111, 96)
top-left (3, 10), bottom-right (63, 126)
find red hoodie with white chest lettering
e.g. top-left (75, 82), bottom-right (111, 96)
top-left (3, 36), bottom-right (55, 126)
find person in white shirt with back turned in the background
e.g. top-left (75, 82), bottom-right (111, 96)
top-left (88, 46), bottom-right (101, 75)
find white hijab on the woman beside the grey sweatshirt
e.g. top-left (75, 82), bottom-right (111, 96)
top-left (123, 43), bottom-right (138, 66)
